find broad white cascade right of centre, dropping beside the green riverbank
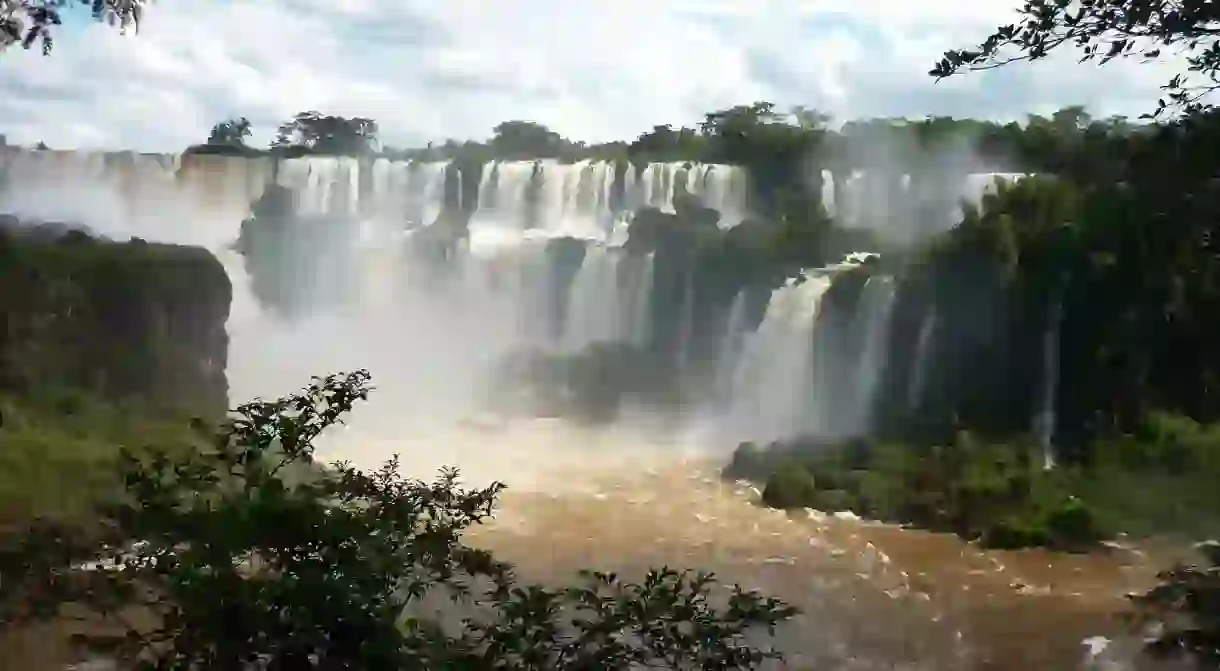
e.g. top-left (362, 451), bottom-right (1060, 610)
top-left (726, 277), bottom-right (831, 440)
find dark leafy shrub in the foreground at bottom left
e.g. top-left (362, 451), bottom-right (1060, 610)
top-left (0, 371), bottom-right (794, 671)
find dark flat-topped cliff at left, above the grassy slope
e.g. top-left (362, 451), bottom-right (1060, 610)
top-left (0, 216), bottom-right (232, 415)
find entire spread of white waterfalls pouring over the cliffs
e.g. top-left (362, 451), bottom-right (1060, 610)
top-left (0, 150), bottom-right (1019, 439)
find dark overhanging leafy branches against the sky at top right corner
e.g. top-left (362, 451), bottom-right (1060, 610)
top-left (928, 0), bottom-right (1220, 113)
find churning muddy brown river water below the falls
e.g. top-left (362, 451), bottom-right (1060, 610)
top-left (0, 421), bottom-right (1185, 671)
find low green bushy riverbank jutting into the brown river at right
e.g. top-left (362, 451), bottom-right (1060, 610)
top-left (722, 414), bottom-right (1220, 551)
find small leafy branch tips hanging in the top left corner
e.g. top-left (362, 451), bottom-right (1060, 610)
top-left (0, 0), bottom-right (146, 54)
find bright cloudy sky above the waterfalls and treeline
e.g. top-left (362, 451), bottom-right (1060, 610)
top-left (0, 0), bottom-right (1195, 151)
